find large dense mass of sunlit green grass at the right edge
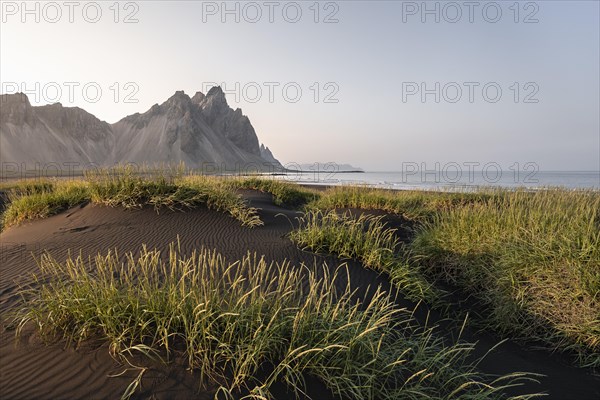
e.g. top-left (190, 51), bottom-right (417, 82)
top-left (410, 189), bottom-right (600, 368)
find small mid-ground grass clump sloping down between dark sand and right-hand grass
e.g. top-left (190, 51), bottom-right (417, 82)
top-left (290, 210), bottom-right (439, 303)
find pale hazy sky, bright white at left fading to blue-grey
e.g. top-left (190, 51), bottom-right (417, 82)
top-left (0, 1), bottom-right (600, 170)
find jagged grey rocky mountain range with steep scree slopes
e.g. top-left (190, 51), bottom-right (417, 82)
top-left (0, 87), bottom-right (283, 172)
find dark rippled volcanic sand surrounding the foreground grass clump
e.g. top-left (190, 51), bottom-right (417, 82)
top-left (0, 191), bottom-right (600, 400)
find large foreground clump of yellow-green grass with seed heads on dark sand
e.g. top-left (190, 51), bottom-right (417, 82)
top-left (17, 245), bottom-right (540, 400)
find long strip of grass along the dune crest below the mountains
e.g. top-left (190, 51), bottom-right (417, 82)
top-left (2, 167), bottom-right (262, 227)
